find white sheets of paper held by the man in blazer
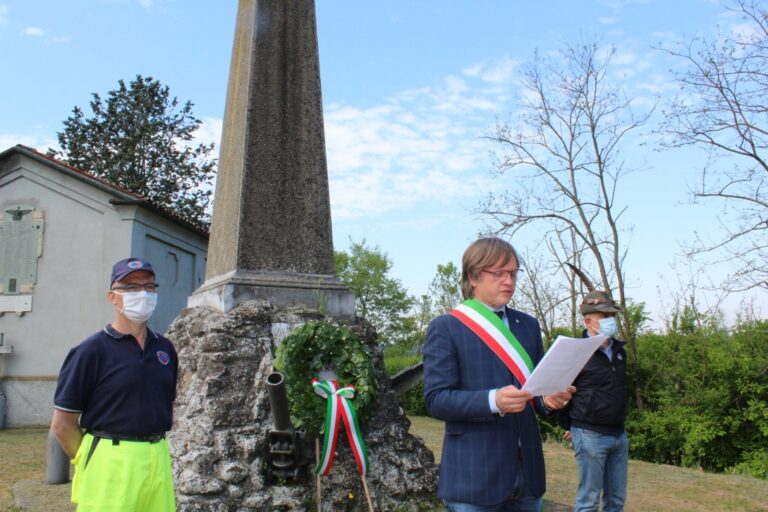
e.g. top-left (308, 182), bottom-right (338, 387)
top-left (522, 335), bottom-right (608, 396)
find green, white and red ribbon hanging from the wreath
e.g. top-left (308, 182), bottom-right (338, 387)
top-left (312, 379), bottom-right (368, 477)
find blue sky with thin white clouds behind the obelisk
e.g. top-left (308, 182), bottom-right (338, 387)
top-left (0, 0), bottom-right (762, 328)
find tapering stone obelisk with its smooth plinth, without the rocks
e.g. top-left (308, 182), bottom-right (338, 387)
top-left (189, 0), bottom-right (354, 319)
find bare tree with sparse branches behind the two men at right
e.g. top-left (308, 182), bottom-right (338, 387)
top-left (479, 42), bottom-right (650, 408)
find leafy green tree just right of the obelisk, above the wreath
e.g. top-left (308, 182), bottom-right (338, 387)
top-left (334, 240), bottom-right (414, 344)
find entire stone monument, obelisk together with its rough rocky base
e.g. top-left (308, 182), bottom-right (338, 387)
top-left (172, 4), bottom-right (437, 512)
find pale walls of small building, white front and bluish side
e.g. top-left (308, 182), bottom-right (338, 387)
top-left (0, 152), bottom-right (208, 427)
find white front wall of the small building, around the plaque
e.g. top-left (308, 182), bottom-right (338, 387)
top-left (0, 155), bottom-right (131, 427)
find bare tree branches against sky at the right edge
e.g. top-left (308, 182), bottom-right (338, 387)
top-left (661, 0), bottom-right (768, 292)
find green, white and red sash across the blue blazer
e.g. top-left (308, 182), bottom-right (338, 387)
top-left (450, 299), bottom-right (533, 386)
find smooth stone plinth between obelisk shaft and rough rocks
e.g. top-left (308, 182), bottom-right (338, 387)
top-left (187, 270), bottom-right (355, 322)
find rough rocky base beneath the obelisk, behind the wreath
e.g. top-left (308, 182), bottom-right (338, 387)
top-left (167, 301), bottom-right (439, 512)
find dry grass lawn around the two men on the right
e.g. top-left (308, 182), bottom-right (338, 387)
top-left (409, 416), bottom-right (768, 512)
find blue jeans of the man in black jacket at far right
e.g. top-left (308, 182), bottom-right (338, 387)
top-left (571, 427), bottom-right (629, 512)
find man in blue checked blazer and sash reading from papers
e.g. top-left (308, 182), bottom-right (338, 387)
top-left (424, 238), bottom-right (575, 512)
